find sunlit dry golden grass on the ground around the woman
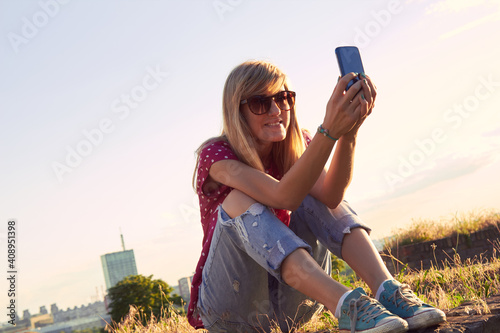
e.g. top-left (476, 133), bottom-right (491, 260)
top-left (106, 212), bottom-right (500, 333)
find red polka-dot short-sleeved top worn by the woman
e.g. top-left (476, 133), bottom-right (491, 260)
top-left (187, 131), bottom-right (311, 328)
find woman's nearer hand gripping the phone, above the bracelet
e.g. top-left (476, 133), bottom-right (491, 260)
top-left (323, 73), bottom-right (371, 138)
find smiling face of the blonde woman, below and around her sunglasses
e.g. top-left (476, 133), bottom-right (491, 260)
top-left (241, 87), bottom-right (291, 149)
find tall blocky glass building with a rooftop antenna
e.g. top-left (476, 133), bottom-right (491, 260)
top-left (101, 235), bottom-right (137, 289)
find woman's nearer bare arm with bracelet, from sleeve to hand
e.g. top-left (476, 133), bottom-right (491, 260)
top-left (209, 73), bottom-right (367, 210)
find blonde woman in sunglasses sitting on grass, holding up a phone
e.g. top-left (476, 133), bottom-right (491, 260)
top-left (188, 61), bottom-right (445, 332)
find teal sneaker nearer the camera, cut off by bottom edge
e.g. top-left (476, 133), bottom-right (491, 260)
top-left (339, 288), bottom-right (408, 333)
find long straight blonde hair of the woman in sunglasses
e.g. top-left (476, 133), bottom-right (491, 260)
top-left (193, 60), bottom-right (305, 186)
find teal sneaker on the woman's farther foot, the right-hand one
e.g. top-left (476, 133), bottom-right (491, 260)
top-left (379, 280), bottom-right (446, 330)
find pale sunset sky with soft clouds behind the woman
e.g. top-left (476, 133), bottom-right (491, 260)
top-left (0, 0), bottom-right (500, 321)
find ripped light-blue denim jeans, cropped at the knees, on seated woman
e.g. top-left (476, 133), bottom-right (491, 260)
top-left (197, 195), bottom-right (370, 332)
